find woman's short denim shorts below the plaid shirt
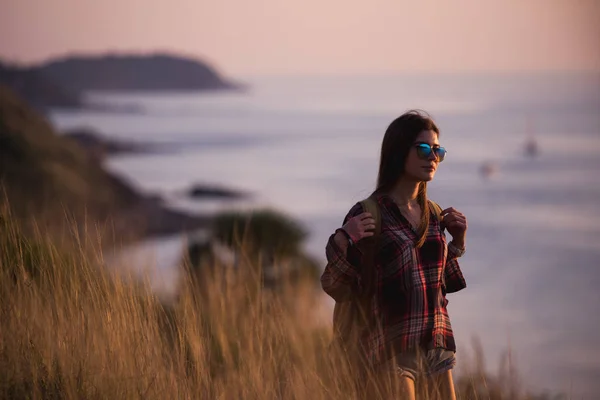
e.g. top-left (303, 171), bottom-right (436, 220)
top-left (381, 348), bottom-right (456, 381)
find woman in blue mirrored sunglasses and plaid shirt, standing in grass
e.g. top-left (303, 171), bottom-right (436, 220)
top-left (321, 111), bottom-right (467, 400)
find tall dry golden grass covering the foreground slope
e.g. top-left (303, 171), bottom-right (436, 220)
top-left (0, 208), bottom-right (564, 400)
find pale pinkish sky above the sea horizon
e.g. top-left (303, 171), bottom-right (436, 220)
top-left (0, 0), bottom-right (600, 75)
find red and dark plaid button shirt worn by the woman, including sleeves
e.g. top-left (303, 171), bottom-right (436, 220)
top-left (321, 195), bottom-right (466, 364)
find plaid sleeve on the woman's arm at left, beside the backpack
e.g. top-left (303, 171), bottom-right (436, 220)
top-left (321, 203), bottom-right (363, 301)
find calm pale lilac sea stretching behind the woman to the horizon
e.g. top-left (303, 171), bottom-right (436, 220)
top-left (50, 72), bottom-right (600, 399)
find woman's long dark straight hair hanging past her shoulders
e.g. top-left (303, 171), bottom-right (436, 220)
top-left (375, 110), bottom-right (440, 247)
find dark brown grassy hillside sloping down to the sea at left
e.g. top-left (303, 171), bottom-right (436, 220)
top-left (0, 85), bottom-right (205, 241)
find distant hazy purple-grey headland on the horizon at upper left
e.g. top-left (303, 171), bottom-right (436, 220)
top-left (0, 53), bottom-right (245, 110)
